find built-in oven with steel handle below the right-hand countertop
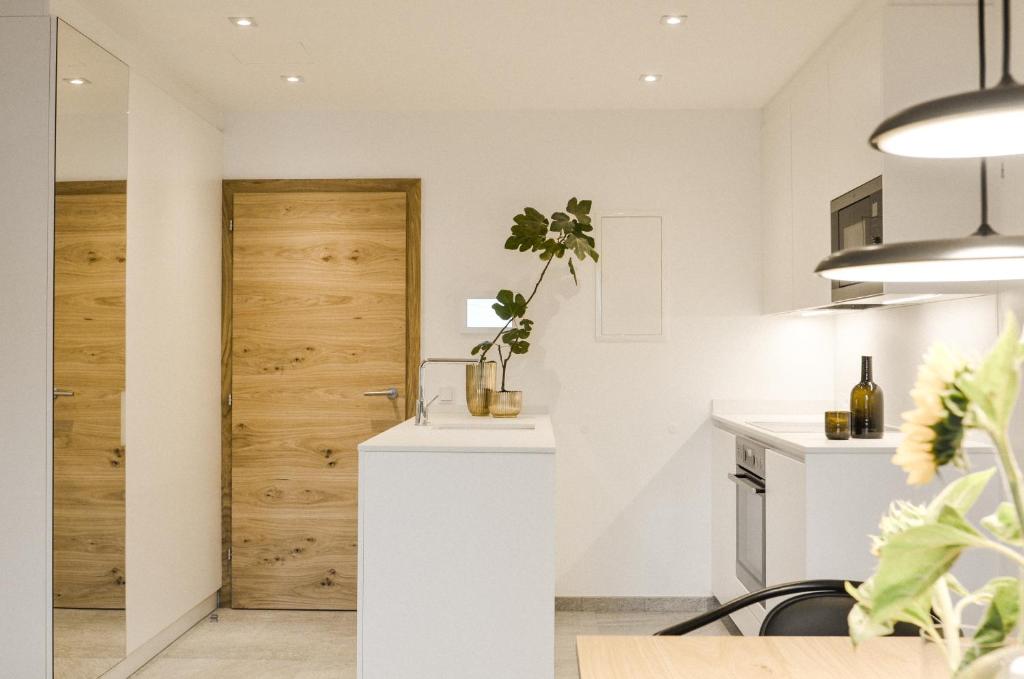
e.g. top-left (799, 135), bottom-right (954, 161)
top-left (729, 436), bottom-right (765, 605)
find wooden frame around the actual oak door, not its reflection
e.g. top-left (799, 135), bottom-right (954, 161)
top-left (219, 179), bottom-right (421, 607)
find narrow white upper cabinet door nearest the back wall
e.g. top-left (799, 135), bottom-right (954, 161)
top-left (761, 91), bottom-right (794, 313)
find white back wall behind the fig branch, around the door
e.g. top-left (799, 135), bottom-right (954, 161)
top-left (224, 111), bottom-right (833, 596)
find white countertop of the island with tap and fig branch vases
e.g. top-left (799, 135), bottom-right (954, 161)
top-left (359, 414), bottom-right (555, 454)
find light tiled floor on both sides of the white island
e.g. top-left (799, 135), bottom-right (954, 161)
top-left (133, 608), bottom-right (728, 679)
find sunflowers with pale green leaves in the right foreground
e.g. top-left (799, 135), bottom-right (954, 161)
top-left (847, 314), bottom-right (1024, 679)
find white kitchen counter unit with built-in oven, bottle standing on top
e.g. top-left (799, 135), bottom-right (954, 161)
top-left (711, 401), bottom-right (1008, 635)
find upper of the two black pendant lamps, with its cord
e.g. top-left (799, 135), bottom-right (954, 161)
top-left (870, 0), bottom-right (1024, 158)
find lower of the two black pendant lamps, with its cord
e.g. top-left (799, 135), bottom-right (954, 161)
top-left (814, 0), bottom-right (1024, 283)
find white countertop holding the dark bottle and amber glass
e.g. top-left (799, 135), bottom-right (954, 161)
top-left (712, 413), bottom-right (994, 458)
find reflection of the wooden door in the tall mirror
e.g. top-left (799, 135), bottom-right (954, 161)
top-left (53, 187), bottom-right (126, 608)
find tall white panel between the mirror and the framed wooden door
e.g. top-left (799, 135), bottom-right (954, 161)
top-left (125, 71), bottom-right (223, 653)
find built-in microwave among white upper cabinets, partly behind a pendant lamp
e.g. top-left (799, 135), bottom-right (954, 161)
top-left (831, 176), bottom-right (883, 302)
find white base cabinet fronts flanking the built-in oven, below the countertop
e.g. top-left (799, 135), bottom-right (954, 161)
top-left (711, 427), bottom-right (1011, 635)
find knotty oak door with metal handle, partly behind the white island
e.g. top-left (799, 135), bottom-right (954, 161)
top-left (230, 190), bottom-right (418, 609)
